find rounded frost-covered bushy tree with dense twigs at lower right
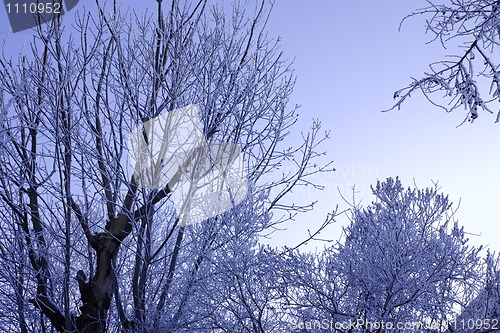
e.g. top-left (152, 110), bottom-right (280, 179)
top-left (283, 178), bottom-right (482, 332)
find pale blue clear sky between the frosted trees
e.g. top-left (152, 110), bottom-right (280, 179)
top-left (0, 0), bottom-right (500, 251)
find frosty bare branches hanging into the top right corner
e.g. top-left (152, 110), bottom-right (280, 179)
top-left (393, 0), bottom-right (500, 122)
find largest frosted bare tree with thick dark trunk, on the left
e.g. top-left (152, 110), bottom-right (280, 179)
top-left (0, 0), bottom-right (331, 333)
